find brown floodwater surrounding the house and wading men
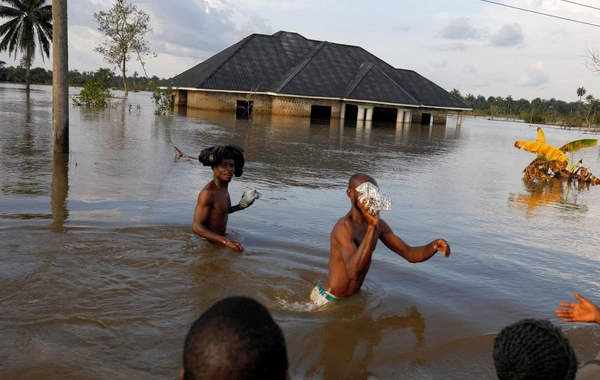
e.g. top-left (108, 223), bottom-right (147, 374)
top-left (0, 84), bottom-right (600, 379)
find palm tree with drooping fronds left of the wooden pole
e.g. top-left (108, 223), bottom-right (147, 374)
top-left (0, 0), bottom-right (52, 92)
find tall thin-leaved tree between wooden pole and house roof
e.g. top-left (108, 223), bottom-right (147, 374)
top-left (94, 0), bottom-right (152, 96)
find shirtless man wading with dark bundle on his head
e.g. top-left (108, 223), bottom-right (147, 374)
top-left (192, 145), bottom-right (260, 252)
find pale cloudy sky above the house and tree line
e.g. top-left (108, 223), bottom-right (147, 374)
top-left (0, 0), bottom-right (600, 102)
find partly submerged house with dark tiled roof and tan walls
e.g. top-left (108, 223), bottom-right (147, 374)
top-left (173, 31), bottom-right (471, 125)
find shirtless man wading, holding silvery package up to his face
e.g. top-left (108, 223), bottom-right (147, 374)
top-left (310, 173), bottom-right (450, 306)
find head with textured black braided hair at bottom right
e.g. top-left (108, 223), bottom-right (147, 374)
top-left (494, 319), bottom-right (577, 380)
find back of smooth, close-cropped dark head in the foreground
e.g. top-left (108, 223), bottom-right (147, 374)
top-left (183, 296), bottom-right (288, 380)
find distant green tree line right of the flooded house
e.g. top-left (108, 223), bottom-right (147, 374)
top-left (451, 87), bottom-right (600, 128)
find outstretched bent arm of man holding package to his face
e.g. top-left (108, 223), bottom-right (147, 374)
top-left (379, 220), bottom-right (450, 263)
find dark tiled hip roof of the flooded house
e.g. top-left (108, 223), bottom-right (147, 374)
top-left (173, 31), bottom-right (470, 109)
